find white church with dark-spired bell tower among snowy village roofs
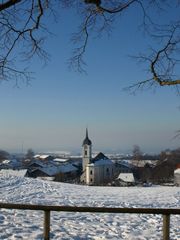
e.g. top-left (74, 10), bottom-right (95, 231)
top-left (81, 129), bottom-right (115, 185)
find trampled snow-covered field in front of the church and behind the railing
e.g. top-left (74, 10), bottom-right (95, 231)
top-left (0, 177), bottom-right (180, 240)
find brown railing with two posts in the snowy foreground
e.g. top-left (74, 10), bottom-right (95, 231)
top-left (0, 203), bottom-right (180, 240)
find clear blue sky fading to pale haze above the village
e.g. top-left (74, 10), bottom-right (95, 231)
top-left (0, 3), bottom-right (180, 153)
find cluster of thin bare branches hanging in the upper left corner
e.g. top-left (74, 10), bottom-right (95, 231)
top-left (0, 0), bottom-right (48, 82)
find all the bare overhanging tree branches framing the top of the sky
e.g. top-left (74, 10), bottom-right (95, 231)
top-left (0, 0), bottom-right (180, 88)
